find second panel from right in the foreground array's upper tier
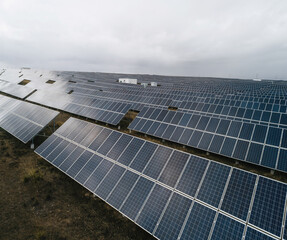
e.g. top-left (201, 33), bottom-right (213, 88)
top-left (221, 169), bottom-right (256, 220)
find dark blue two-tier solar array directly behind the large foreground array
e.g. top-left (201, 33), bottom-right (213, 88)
top-left (128, 108), bottom-right (287, 172)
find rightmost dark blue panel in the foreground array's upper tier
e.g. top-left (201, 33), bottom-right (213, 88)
top-left (249, 177), bottom-right (287, 236)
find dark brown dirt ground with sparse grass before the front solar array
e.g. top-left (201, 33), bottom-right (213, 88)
top-left (0, 126), bottom-right (153, 240)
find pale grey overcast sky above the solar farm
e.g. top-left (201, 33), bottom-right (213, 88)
top-left (0, 0), bottom-right (287, 79)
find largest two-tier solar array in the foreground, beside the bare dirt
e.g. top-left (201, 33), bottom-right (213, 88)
top-left (35, 118), bottom-right (287, 239)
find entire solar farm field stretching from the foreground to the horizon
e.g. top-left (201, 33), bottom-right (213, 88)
top-left (0, 69), bottom-right (287, 240)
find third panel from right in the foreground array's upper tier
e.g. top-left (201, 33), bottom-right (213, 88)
top-left (197, 163), bottom-right (230, 207)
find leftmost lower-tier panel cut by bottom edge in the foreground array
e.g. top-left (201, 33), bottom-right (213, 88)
top-left (155, 193), bottom-right (192, 239)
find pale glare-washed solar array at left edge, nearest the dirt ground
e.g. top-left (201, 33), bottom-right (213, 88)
top-left (0, 96), bottom-right (59, 143)
